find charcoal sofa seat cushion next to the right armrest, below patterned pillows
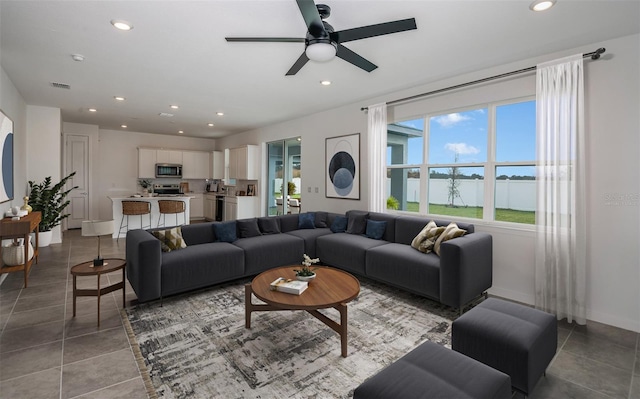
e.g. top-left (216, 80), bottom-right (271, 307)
top-left (365, 243), bottom-right (440, 300)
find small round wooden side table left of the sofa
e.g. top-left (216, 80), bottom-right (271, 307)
top-left (71, 258), bottom-right (127, 327)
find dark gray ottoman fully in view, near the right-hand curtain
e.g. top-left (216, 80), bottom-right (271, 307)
top-left (451, 298), bottom-right (558, 395)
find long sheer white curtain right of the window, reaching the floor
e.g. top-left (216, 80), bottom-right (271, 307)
top-left (535, 54), bottom-right (586, 324)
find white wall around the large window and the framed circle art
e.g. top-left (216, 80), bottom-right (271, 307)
top-left (217, 35), bottom-right (640, 331)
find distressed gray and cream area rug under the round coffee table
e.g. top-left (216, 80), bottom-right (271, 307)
top-left (123, 280), bottom-right (456, 399)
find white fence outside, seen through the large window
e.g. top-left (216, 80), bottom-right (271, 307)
top-left (387, 178), bottom-right (536, 211)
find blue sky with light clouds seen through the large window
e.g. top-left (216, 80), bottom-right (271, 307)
top-left (398, 101), bottom-right (536, 175)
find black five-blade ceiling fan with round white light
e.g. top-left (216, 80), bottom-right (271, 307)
top-left (225, 0), bottom-right (417, 76)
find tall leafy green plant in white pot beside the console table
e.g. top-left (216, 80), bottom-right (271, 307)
top-left (29, 172), bottom-right (78, 247)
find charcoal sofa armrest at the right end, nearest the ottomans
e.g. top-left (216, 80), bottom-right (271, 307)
top-left (440, 232), bottom-right (493, 308)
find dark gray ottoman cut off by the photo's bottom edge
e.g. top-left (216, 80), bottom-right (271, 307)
top-left (353, 341), bottom-right (511, 399)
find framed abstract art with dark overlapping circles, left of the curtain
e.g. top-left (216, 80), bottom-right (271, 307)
top-left (325, 133), bottom-right (360, 200)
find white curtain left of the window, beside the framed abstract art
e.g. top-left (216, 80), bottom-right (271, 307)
top-left (367, 103), bottom-right (387, 212)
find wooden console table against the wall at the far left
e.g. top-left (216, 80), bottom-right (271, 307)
top-left (0, 211), bottom-right (42, 288)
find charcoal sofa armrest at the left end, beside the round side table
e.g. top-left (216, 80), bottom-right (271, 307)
top-left (126, 230), bottom-right (162, 302)
